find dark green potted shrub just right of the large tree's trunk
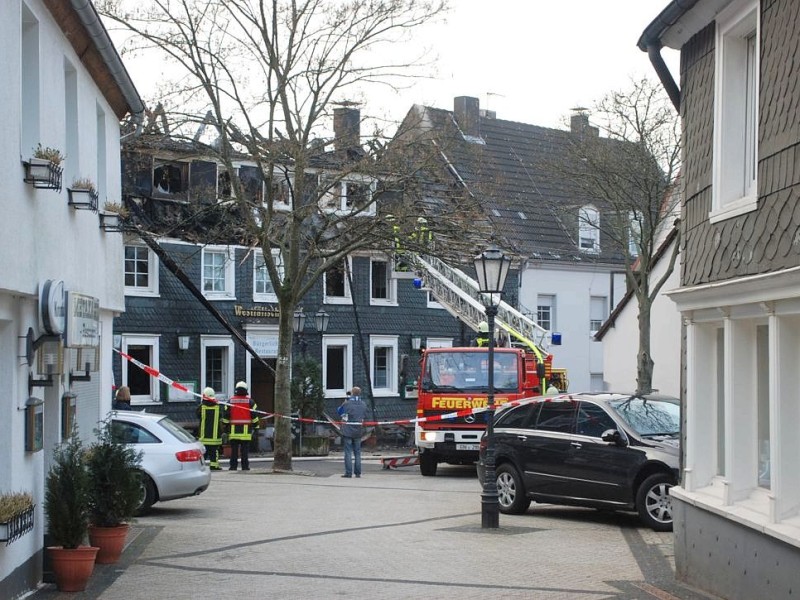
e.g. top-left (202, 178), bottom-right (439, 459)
top-left (290, 356), bottom-right (330, 456)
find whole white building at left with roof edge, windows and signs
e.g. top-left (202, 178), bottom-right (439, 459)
top-left (0, 0), bottom-right (143, 598)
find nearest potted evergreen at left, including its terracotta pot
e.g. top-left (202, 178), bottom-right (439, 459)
top-left (44, 433), bottom-right (98, 592)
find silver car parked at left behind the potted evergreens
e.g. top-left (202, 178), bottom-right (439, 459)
top-left (111, 410), bottom-right (211, 514)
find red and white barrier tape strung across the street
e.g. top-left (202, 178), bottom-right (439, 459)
top-left (114, 348), bottom-right (572, 427)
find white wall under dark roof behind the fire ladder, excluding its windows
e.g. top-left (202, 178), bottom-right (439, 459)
top-left (519, 263), bottom-right (625, 392)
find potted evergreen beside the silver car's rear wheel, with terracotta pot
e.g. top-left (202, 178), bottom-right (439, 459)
top-left (86, 419), bottom-right (142, 564)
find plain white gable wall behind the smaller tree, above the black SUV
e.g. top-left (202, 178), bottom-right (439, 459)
top-left (602, 241), bottom-right (681, 398)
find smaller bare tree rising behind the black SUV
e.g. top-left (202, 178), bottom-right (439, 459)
top-left (556, 79), bottom-right (680, 393)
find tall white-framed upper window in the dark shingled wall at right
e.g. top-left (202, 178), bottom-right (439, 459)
top-left (710, 0), bottom-right (760, 222)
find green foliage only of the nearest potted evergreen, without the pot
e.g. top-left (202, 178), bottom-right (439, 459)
top-left (44, 433), bottom-right (89, 548)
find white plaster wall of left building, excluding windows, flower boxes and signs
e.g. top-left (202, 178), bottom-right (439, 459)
top-left (0, 0), bottom-right (124, 582)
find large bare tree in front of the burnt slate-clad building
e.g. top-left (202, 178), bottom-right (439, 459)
top-left (99, 0), bottom-right (482, 470)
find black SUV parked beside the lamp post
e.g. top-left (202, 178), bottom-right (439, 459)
top-left (478, 393), bottom-right (681, 531)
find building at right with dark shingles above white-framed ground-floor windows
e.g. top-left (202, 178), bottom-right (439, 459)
top-left (639, 0), bottom-right (800, 599)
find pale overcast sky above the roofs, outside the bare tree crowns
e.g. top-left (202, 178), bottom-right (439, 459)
top-left (119, 0), bottom-right (679, 133)
